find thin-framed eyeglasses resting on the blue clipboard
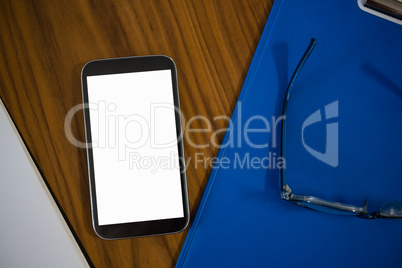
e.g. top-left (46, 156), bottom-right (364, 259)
top-left (281, 38), bottom-right (402, 219)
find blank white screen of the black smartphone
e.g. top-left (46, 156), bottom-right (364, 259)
top-left (87, 70), bottom-right (184, 225)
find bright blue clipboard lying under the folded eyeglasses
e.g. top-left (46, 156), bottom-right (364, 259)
top-left (176, 0), bottom-right (402, 267)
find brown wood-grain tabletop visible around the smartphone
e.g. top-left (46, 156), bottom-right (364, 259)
top-left (0, 0), bottom-right (273, 267)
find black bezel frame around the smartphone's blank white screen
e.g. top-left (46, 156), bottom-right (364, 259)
top-left (81, 55), bottom-right (190, 239)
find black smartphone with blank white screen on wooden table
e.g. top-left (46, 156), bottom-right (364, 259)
top-left (82, 56), bottom-right (189, 239)
